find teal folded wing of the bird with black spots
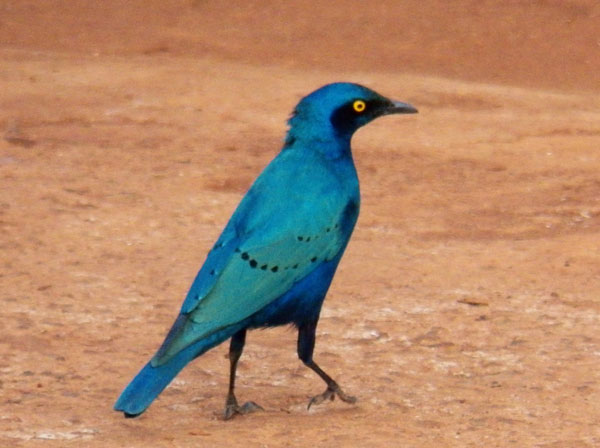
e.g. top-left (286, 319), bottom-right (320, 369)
top-left (157, 150), bottom-right (358, 363)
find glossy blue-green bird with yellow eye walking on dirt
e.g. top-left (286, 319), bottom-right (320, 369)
top-left (114, 82), bottom-right (417, 420)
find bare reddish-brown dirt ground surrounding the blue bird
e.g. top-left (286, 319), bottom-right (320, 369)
top-left (0, 0), bottom-right (600, 448)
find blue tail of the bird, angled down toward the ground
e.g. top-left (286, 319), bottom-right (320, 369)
top-left (114, 318), bottom-right (239, 417)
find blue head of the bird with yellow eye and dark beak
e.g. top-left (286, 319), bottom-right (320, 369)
top-left (286, 83), bottom-right (417, 156)
